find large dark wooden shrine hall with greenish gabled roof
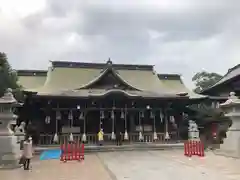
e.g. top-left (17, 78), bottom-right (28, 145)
top-left (18, 59), bottom-right (205, 143)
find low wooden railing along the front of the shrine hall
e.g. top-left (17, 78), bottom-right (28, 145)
top-left (38, 132), bottom-right (180, 145)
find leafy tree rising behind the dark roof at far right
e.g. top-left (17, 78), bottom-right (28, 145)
top-left (192, 71), bottom-right (223, 93)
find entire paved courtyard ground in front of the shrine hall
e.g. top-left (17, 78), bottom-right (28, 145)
top-left (0, 150), bottom-right (240, 180)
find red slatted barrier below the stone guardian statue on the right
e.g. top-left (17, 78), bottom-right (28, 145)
top-left (184, 140), bottom-right (205, 157)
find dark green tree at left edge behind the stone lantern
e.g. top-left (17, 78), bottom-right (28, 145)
top-left (0, 52), bottom-right (21, 99)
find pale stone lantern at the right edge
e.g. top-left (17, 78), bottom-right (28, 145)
top-left (218, 92), bottom-right (240, 158)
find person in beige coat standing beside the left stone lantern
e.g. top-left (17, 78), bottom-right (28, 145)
top-left (23, 137), bottom-right (33, 170)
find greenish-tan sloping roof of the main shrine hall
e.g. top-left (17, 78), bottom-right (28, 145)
top-left (20, 61), bottom-right (205, 99)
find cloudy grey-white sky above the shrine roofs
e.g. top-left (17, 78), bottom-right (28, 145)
top-left (0, 0), bottom-right (240, 88)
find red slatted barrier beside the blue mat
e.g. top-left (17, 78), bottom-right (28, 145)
top-left (60, 143), bottom-right (84, 162)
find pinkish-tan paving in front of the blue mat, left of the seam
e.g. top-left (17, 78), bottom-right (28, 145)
top-left (0, 155), bottom-right (111, 180)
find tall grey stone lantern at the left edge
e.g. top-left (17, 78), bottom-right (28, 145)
top-left (0, 89), bottom-right (21, 169)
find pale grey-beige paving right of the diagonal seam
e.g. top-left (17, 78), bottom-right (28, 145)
top-left (98, 150), bottom-right (240, 180)
